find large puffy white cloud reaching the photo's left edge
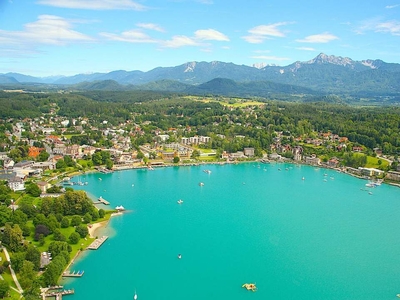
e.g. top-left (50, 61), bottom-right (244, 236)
top-left (0, 15), bottom-right (94, 47)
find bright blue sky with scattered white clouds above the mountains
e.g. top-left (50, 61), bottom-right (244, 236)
top-left (0, 0), bottom-right (400, 77)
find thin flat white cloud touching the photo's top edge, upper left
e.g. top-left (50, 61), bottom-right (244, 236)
top-left (37, 0), bottom-right (146, 10)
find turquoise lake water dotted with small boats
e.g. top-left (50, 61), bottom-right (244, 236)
top-left (62, 163), bottom-right (400, 300)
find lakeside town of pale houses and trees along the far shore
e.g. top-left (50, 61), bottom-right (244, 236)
top-left (0, 101), bottom-right (400, 193)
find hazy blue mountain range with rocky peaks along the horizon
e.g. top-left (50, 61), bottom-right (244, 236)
top-left (0, 53), bottom-right (400, 96)
